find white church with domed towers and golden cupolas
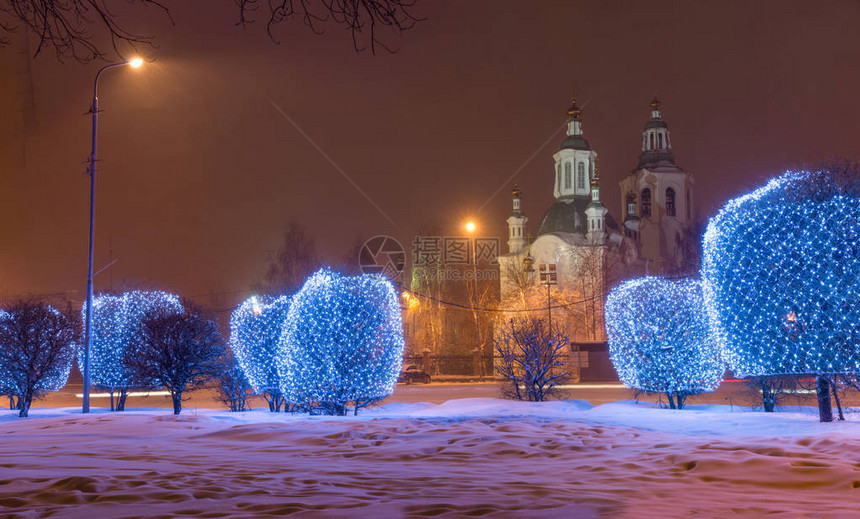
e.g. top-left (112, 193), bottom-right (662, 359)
top-left (499, 98), bottom-right (696, 341)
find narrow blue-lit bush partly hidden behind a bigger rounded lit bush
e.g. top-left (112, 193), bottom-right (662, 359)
top-left (230, 296), bottom-right (291, 412)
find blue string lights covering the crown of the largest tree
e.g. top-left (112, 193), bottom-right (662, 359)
top-left (702, 171), bottom-right (860, 377)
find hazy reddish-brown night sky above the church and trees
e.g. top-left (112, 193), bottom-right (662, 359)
top-left (0, 0), bottom-right (860, 306)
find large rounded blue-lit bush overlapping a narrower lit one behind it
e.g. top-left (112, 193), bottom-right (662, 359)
top-left (278, 270), bottom-right (403, 414)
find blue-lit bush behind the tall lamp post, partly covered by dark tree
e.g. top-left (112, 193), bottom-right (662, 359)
top-left (78, 291), bottom-right (182, 411)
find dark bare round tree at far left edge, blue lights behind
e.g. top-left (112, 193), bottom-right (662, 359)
top-left (0, 301), bottom-right (78, 418)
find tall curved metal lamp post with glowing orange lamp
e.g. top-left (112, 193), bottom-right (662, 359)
top-left (81, 58), bottom-right (143, 413)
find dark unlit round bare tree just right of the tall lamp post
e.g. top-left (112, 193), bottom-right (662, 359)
top-left (129, 301), bottom-right (226, 414)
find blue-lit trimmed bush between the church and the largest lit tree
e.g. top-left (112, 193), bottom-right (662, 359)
top-left (605, 277), bottom-right (725, 408)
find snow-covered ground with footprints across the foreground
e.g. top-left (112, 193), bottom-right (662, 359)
top-left (0, 398), bottom-right (860, 518)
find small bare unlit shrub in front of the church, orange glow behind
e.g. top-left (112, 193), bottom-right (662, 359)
top-left (496, 318), bottom-right (571, 402)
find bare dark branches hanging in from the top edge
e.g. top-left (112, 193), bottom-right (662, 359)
top-left (0, 0), bottom-right (421, 62)
